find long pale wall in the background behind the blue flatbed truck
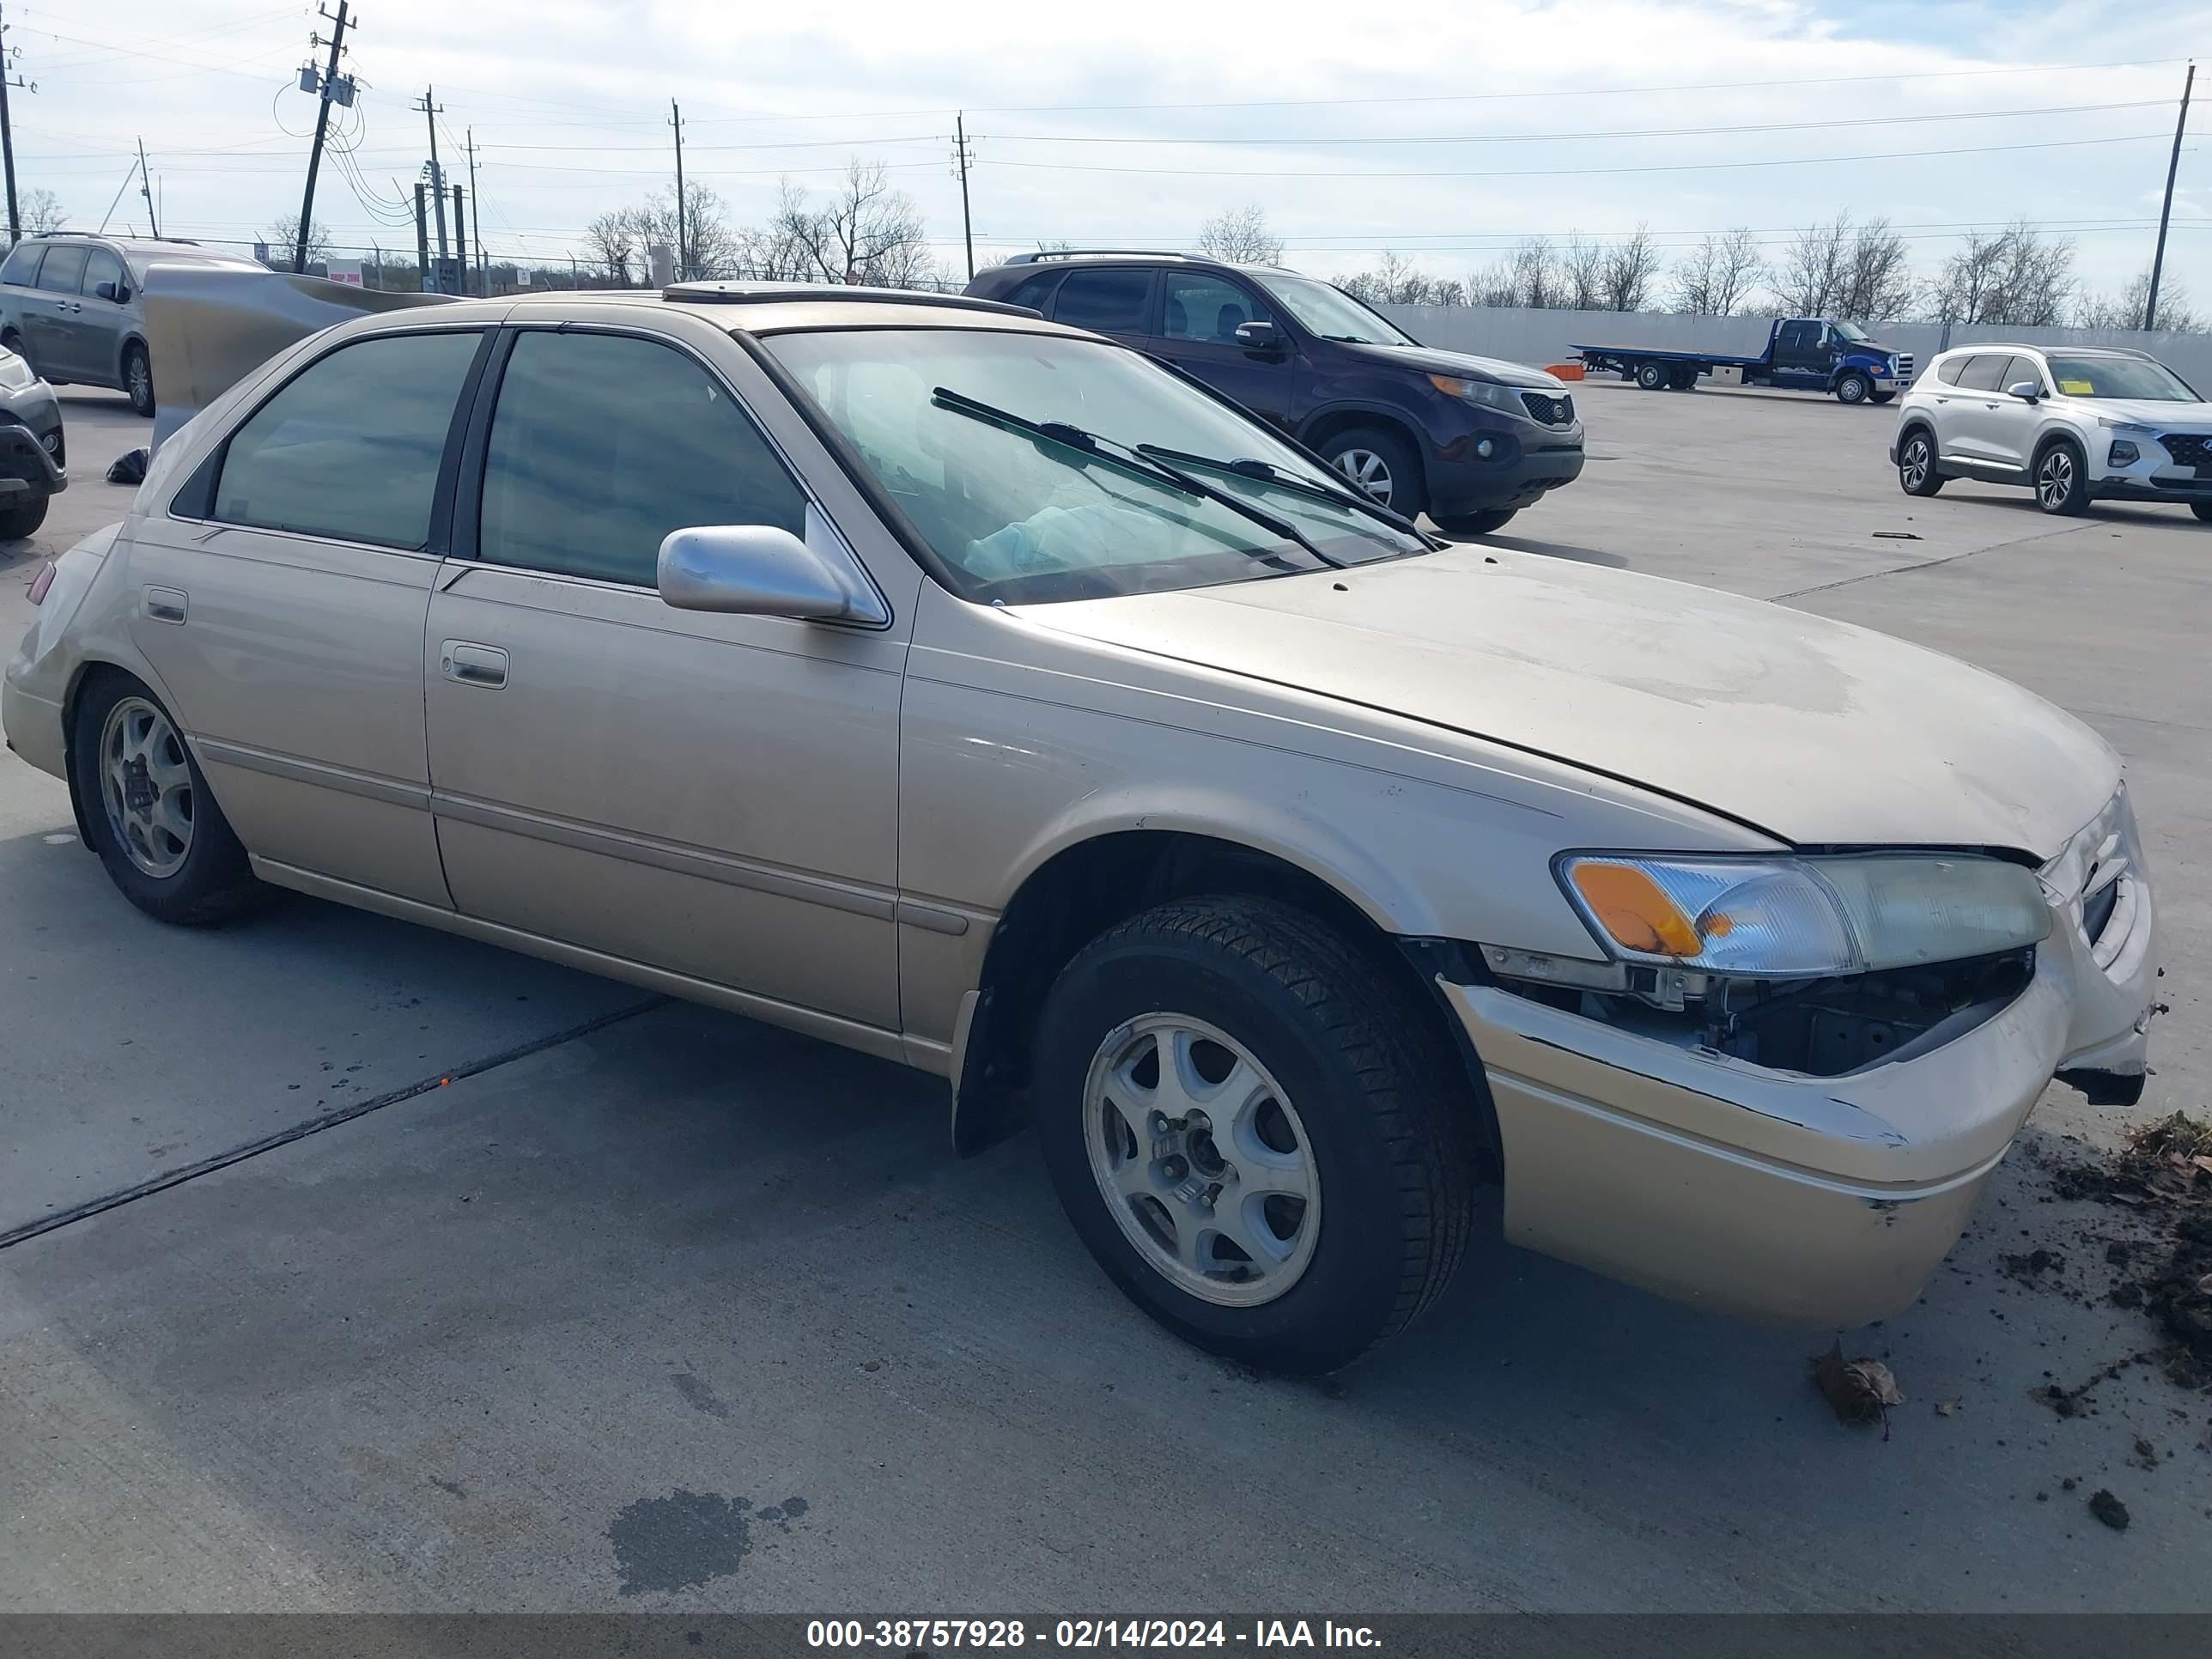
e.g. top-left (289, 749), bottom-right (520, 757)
top-left (1376, 305), bottom-right (2212, 392)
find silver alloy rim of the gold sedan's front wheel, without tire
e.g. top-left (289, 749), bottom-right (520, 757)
top-left (1084, 1013), bottom-right (1321, 1307)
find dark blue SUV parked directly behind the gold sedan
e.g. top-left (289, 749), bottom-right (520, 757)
top-left (967, 250), bottom-right (1582, 535)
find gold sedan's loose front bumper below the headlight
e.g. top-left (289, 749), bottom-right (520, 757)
top-left (1440, 805), bottom-right (2157, 1328)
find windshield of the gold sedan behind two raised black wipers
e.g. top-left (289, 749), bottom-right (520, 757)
top-left (763, 330), bottom-right (1427, 604)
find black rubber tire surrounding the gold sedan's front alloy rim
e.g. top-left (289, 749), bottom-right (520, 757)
top-left (1033, 898), bottom-right (1478, 1376)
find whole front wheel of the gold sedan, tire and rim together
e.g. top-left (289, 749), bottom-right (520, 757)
top-left (1033, 898), bottom-right (1475, 1376)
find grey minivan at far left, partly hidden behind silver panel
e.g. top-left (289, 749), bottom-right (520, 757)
top-left (0, 232), bottom-right (254, 416)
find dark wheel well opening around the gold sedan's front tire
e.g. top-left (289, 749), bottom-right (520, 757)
top-left (951, 825), bottom-right (1498, 1172)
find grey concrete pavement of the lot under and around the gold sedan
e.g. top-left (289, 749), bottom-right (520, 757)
top-left (0, 385), bottom-right (2212, 1613)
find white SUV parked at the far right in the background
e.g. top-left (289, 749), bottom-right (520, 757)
top-left (1889, 345), bottom-right (2212, 520)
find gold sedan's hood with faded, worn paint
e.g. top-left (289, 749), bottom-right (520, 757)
top-left (1022, 546), bottom-right (2119, 858)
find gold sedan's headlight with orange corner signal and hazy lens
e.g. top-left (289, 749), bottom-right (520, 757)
top-left (1558, 854), bottom-right (2051, 980)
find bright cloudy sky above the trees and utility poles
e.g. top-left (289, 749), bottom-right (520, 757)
top-left (4, 0), bottom-right (2212, 299)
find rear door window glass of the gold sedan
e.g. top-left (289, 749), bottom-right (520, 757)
top-left (215, 330), bottom-right (482, 550)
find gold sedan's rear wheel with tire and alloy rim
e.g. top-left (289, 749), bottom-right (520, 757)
top-left (69, 672), bottom-right (270, 927)
